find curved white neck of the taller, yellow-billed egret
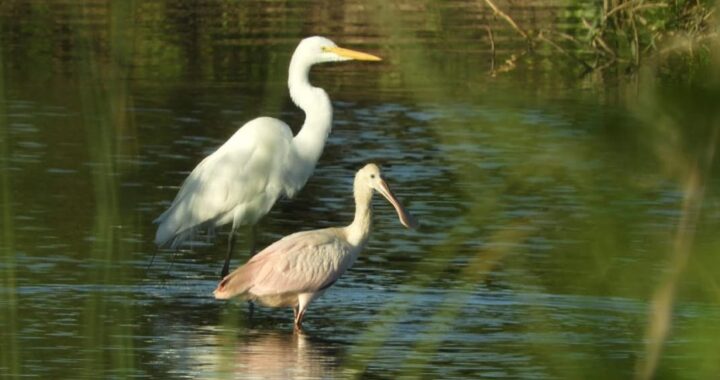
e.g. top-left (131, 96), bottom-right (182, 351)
top-left (288, 55), bottom-right (332, 166)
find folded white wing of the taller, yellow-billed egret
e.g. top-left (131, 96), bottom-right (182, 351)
top-left (155, 117), bottom-right (293, 244)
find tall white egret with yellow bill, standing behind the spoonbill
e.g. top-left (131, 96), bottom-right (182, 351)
top-left (154, 36), bottom-right (380, 277)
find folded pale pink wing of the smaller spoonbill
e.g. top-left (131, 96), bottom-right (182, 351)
top-left (216, 228), bottom-right (354, 298)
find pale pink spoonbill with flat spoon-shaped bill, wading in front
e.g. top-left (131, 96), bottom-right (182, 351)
top-left (214, 164), bottom-right (415, 329)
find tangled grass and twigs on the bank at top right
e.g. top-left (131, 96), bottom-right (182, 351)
top-left (482, 0), bottom-right (718, 75)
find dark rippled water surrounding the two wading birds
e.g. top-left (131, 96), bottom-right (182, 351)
top-left (0, 1), bottom-right (720, 379)
